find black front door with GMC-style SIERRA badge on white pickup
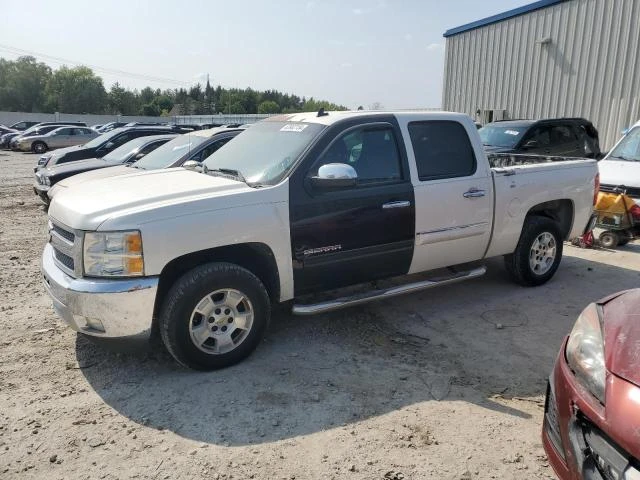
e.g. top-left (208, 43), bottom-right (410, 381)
top-left (290, 119), bottom-right (415, 295)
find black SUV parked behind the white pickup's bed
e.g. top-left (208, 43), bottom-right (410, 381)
top-left (479, 118), bottom-right (601, 159)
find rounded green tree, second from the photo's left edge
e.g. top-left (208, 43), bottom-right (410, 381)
top-left (45, 65), bottom-right (107, 113)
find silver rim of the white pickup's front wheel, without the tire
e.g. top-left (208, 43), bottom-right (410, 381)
top-left (189, 288), bottom-right (254, 355)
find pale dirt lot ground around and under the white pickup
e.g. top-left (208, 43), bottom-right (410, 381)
top-left (0, 152), bottom-right (640, 479)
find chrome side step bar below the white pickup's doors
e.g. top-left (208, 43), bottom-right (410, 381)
top-left (292, 267), bottom-right (487, 315)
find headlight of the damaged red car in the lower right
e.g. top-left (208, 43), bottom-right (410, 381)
top-left (566, 303), bottom-right (607, 405)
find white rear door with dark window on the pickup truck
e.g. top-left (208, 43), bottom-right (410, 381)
top-left (404, 120), bottom-right (493, 273)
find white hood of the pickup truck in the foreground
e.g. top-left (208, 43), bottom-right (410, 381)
top-left (49, 167), bottom-right (255, 230)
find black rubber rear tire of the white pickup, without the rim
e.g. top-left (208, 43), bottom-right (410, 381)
top-left (504, 215), bottom-right (563, 287)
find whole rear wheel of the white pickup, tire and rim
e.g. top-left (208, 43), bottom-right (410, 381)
top-left (504, 216), bottom-right (562, 287)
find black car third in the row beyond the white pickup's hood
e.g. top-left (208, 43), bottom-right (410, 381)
top-left (34, 126), bottom-right (191, 171)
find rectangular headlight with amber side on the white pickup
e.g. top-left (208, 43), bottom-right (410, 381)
top-left (83, 230), bottom-right (144, 277)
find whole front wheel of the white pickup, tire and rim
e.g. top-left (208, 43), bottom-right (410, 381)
top-left (159, 263), bottom-right (271, 370)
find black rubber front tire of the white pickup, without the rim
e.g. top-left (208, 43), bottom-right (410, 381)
top-left (159, 263), bottom-right (271, 370)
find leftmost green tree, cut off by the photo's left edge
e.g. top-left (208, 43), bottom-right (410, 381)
top-left (0, 56), bottom-right (51, 112)
